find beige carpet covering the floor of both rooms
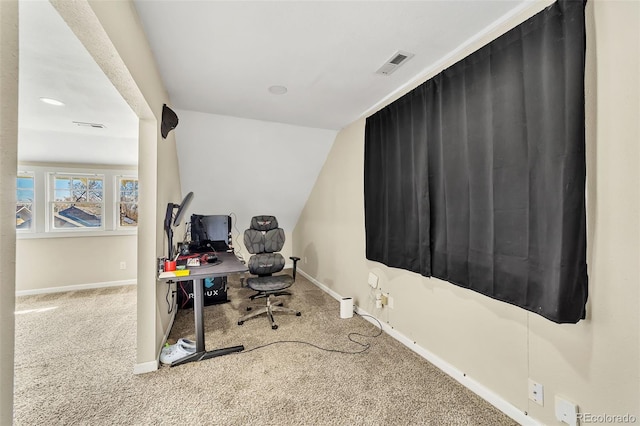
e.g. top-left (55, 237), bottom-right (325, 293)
top-left (14, 277), bottom-right (516, 426)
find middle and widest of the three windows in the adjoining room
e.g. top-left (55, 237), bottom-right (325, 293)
top-left (49, 173), bottom-right (104, 230)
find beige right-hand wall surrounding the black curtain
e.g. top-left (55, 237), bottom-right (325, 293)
top-left (293, 1), bottom-right (640, 425)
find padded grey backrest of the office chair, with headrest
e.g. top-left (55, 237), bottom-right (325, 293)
top-left (244, 216), bottom-right (285, 276)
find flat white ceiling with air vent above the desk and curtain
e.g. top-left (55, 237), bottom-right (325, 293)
top-left (134, 0), bottom-right (531, 130)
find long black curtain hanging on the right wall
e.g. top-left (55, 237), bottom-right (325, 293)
top-left (364, 0), bottom-right (587, 323)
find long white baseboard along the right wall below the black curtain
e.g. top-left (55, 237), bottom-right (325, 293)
top-left (298, 269), bottom-right (540, 426)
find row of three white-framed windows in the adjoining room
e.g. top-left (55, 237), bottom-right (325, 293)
top-left (17, 166), bottom-right (139, 239)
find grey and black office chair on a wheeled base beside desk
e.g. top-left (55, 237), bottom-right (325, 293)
top-left (238, 216), bottom-right (301, 330)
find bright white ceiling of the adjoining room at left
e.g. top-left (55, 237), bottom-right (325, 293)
top-left (18, 0), bottom-right (138, 165)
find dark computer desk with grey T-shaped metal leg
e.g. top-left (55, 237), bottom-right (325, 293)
top-left (158, 252), bottom-right (248, 367)
